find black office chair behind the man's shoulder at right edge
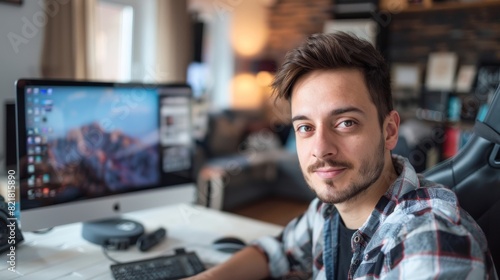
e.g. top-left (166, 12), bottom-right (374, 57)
top-left (423, 86), bottom-right (500, 272)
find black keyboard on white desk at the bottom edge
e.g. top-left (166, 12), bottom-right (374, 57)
top-left (110, 252), bottom-right (205, 280)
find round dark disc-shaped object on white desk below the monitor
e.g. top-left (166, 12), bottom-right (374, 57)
top-left (82, 218), bottom-right (144, 250)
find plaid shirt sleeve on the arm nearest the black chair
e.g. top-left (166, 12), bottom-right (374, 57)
top-left (383, 209), bottom-right (497, 280)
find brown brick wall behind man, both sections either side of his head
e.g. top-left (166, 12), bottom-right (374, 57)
top-left (264, 0), bottom-right (500, 65)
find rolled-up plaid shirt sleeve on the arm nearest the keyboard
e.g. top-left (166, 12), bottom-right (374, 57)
top-left (253, 199), bottom-right (321, 278)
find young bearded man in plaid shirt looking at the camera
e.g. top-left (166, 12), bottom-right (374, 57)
top-left (187, 33), bottom-right (497, 280)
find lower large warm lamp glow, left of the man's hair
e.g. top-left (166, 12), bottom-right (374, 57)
top-left (231, 73), bottom-right (263, 109)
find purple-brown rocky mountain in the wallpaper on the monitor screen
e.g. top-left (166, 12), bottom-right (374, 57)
top-left (48, 123), bottom-right (160, 196)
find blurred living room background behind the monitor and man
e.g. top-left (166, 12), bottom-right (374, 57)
top-left (0, 0), bottom-right (500, 225)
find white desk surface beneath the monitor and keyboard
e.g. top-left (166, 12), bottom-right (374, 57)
top-left (0, 204), bottom-right (282, 280)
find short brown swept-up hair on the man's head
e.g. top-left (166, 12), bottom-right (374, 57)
top-left (272, 32), bottom-right (393, 125)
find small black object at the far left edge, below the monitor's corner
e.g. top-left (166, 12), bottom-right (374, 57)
top-left (0, 195), bottom-right (24, 255)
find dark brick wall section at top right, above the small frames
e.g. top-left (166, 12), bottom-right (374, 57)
top-left (387, 5), bottom-right (500, 65)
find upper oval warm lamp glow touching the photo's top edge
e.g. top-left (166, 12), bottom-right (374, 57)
top-left (231, 1), bottom-right (268, 57)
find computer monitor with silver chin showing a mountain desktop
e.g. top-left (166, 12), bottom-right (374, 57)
top-left (16, 79), bottom-right (196, 234)
